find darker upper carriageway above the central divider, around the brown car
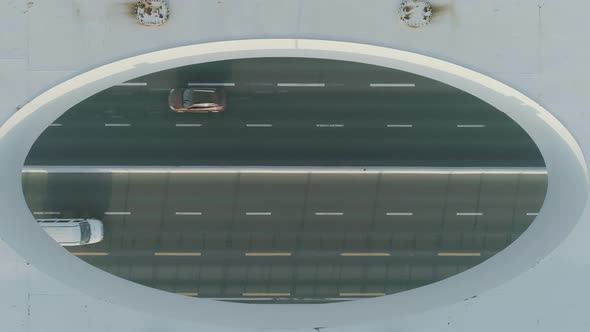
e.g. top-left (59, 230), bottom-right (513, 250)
top-left (26, 59), bottom-right (544, 167)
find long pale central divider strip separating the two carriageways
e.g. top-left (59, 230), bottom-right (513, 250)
top-left (23, 165), bottom-right (547, 175)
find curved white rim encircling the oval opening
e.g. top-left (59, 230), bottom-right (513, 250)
top-left (0, 39), bottom-right (588, 328)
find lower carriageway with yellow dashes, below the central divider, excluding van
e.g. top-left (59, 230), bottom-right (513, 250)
top-left (23, 169), bottom-right (547, 303)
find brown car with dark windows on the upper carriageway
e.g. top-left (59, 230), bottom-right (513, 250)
top-left (168, 88), bottom-right (225, 113)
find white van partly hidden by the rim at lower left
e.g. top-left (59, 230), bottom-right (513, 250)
top-left (37, 219), bottom-right (104, 246)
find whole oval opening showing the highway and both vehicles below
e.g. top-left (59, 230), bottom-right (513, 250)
top-left (23, 58), bottom-right (547, 304)
